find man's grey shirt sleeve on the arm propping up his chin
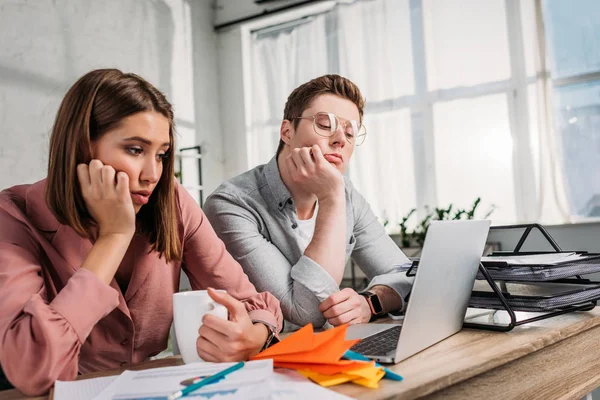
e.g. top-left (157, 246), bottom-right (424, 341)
top-left (204, 191), bottom-right (339, 327)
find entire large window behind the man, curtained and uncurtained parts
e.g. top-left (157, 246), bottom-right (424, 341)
top-left (249, 0), bottom-right (600, 231)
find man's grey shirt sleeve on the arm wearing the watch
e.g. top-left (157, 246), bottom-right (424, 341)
top-left (347, 181), bottom-right (414, 308)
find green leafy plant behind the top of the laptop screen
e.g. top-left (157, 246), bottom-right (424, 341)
top-left (398, 197), bottom-right (496, 247)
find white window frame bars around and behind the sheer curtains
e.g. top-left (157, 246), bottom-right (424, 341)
top-left (232, 0), bottom-right (584, 224)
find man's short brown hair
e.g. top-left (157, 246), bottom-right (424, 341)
top-left (276, 75), bottom-right (365, 156)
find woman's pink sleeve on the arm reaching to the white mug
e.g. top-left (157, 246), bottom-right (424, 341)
top-left (177, 185), bottom-right (283, 332)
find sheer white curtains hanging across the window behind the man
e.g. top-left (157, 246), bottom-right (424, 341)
top-left (249, 0), bottom-right (569, 227)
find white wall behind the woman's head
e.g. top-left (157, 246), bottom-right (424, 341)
top-left (0, 0), bottom-right (223, 197)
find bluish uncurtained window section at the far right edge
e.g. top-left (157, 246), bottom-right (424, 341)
top-left (544, 0), bottom-right (600, 218)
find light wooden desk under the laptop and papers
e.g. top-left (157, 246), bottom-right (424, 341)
top-left (0, 307), bottom-right (600, 400)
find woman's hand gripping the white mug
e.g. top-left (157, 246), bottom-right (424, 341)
top-left (196, 289), bottom-right (269, 362)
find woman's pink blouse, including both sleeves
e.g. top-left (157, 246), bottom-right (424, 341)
top-left (0, 180), bottom-right (282, 395)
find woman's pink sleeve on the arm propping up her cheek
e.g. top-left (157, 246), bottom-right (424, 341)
top-left (0, 210), bottom-right (119, 396)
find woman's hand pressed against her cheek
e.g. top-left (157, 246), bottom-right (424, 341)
top-left (77, 160), bottom-right (135, 236)
